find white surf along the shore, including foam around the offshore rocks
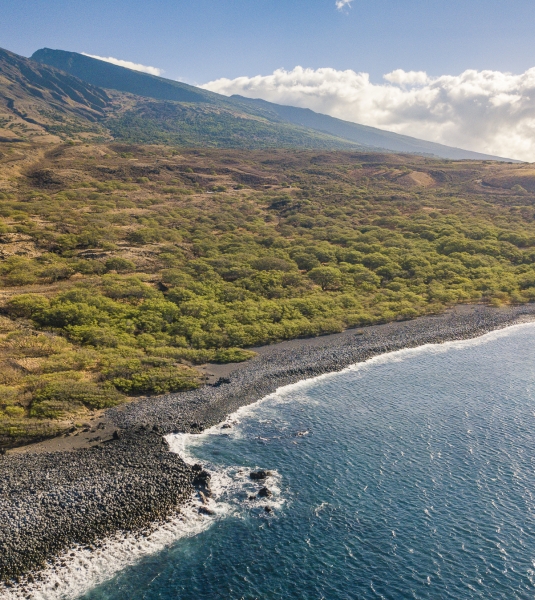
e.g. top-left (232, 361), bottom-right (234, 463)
top-left (0, 322), bottom-right (535, 600)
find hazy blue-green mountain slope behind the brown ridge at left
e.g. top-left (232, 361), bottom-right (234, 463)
top-left (32, 48), bottom-right (508, 160)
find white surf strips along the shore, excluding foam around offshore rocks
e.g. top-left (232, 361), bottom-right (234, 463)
top-left (4, 322), bottom-right (535, 600)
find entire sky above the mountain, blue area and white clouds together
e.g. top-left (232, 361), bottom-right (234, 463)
top-left (0, 0), bottom-right (535, 161)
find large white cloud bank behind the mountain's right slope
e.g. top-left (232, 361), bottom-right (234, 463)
top-left (202, 67), bottom-right (535, 162)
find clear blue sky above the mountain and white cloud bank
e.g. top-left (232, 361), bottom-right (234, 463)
top-left (0, 0), bottom-right (535, 83)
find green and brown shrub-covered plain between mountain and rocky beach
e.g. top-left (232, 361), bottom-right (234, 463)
top-left (0, 145), bottom-right (535, 443)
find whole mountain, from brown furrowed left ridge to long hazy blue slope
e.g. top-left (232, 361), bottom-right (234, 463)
top-left (0, 48), bottom-right (508, 160)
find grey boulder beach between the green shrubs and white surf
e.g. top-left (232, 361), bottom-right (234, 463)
top-left (0, 304), bottom-right (535, 584)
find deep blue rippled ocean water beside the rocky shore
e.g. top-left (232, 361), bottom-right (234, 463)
top-left (84, 325), bottom-right (535, 600)
